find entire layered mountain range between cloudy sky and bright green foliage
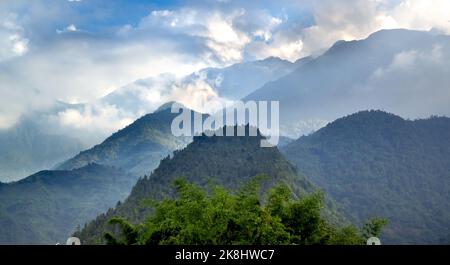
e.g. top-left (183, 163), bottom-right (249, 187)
top-left (0, 27), bottom-right (450, 244)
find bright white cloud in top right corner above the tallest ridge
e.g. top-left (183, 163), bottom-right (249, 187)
top-left (301, 0), bottom-right (450, 55)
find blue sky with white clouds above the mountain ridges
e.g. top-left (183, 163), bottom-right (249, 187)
top-left (0, 0), bottom-right (450, 137)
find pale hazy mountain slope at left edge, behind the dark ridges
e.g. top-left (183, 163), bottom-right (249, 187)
top-left (0, 109), bottom-right (83, 182)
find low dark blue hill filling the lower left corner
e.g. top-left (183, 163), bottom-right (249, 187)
top-left (0, 164), bottom-right (137, 245)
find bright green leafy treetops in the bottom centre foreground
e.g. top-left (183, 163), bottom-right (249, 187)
top-left (104, 179), bottom-right (376, 245)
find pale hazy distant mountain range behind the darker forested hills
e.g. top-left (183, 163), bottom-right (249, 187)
top-left (0, 29), bottom-right (450, 181)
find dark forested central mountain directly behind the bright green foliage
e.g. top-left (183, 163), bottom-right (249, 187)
top-left (76, 127), bottom-right (324, 244)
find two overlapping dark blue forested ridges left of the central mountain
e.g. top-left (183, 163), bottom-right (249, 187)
top-left (0, 103), bottom-right (202, 244)
